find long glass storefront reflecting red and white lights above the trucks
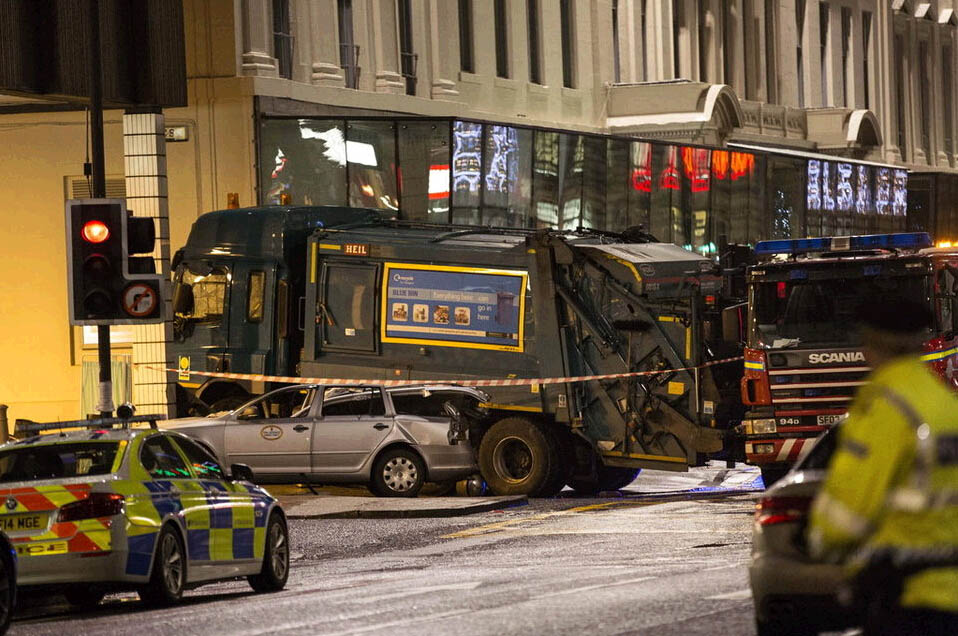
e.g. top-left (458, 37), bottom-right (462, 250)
top-left (258, 117), bottom-right (907, 254)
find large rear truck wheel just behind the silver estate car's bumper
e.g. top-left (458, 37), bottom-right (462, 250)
top-left (479, 417), bottom-right (556, 496)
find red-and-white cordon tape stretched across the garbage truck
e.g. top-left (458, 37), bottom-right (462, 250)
top-left (141, 356), bottom-right (743, 387)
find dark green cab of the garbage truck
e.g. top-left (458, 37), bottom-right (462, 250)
top-left (169, 206), bottom-right (381, 415)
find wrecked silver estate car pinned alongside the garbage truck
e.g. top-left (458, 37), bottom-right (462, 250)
top-left (164, 385), bottom-right (488, 497)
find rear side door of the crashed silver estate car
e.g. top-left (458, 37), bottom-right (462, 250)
top-left (312, 386), bottom-right (395, 475)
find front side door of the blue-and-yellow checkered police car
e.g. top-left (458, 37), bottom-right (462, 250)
top-left (175, 436), bottom-right (262, 577)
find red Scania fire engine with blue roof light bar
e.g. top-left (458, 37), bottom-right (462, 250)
top-left (741, 232), bottom-right (958, 486)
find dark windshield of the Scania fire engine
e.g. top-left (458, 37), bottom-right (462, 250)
top-left (748, 276), bottom-right (927, 349)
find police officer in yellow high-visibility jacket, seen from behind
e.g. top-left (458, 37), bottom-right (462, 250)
top-left (808, 299), bottom-right (958, 635)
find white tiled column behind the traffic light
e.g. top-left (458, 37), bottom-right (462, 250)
top-left (123, 113), bottom-right (176, 416)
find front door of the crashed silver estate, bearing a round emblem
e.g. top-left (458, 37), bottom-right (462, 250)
top-left (224, 386), bottom-right (316, 481)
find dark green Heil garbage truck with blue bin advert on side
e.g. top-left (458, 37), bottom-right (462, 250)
top-left (174, 209), bottom-right (728, 496)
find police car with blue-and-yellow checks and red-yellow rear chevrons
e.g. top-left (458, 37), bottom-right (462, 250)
top-left (0, 416), bottom-right (289, 606)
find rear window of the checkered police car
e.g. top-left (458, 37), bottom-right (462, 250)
top-left (0, 442), bottom-right (120, 482)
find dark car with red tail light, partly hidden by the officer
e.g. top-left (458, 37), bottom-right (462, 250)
top-left (749, 426), bottom-right (860, 636)
